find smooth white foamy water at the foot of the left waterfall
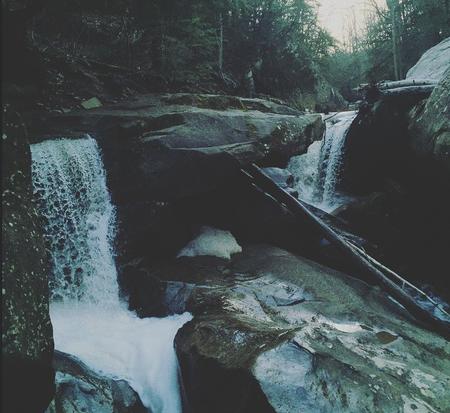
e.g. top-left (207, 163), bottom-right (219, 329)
top-left (50, 303), bottom-right (192, 413)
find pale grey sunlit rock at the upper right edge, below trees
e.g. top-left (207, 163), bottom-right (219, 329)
top-left (406, 37), bottom-right (450, 83)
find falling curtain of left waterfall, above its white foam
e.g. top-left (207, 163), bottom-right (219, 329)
top-left (31, 138), bottom-right (119, 305)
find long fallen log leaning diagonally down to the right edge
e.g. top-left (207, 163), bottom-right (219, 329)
top-left (243, 164), bottom-right (450, 340)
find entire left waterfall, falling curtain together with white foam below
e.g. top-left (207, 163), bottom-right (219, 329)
top-left (31, 137), bottom-right (191, 413)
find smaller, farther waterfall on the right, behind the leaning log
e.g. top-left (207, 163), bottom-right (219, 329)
top-left (288, 112), bottom-right (356, 212)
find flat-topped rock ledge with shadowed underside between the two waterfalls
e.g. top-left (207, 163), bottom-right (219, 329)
top-left (31, 94), bottom-right (324, 262)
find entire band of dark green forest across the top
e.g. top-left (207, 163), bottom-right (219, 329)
top-left (4, 0), bottom-right (450, 109)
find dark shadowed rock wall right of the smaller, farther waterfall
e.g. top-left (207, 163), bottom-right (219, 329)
top-left (340, 83), bottom-right (450, 297)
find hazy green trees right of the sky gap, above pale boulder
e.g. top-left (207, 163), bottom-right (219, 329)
top-left (325, 0), bottom-right (450, 99)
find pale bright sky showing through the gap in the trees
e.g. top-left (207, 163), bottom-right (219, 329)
top-left (318, 0), bottom-right (386, 41)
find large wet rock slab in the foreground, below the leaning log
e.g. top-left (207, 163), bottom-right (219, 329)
top-left (138, 245), bottom-right (450, 413)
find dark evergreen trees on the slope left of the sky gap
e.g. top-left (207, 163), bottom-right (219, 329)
top-left (35, 0), bottom-right (333, 98)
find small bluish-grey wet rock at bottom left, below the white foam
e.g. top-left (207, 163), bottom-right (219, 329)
top-left (46, 351), bottom-right (148, 413)
